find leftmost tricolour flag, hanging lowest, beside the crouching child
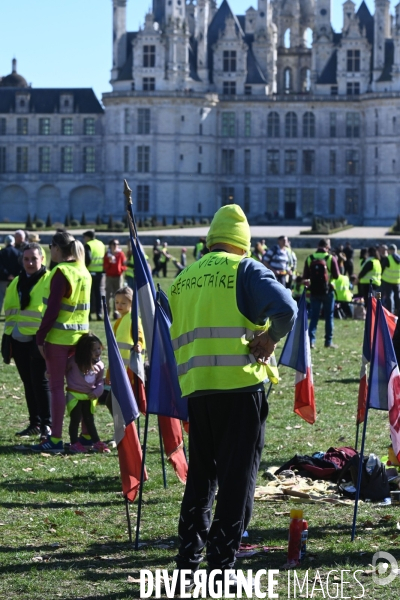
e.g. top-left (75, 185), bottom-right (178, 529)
top-left (103, 298), bottom-right (147, 502)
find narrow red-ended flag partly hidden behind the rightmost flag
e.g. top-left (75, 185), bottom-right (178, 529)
top-left (357, 286), bottom-right (397, 424)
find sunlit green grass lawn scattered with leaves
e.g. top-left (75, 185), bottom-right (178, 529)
top-left (0, 249), bottom-right (400, 600)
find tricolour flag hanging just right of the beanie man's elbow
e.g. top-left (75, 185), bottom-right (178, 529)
top-left (279, 291), bottom-right (317, 425)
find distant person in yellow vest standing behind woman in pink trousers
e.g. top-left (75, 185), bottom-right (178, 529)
top-left (83, 230), bottom-right (106, 321)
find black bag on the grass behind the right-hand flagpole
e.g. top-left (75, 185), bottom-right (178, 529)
top-left (338, 453), bottom-right (390, 502)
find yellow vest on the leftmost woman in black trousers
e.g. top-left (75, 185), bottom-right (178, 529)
top-left (4, 272), bottom-right (50, 335)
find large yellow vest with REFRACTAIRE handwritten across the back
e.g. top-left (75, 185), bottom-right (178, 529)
top-left (168, 252), bottom-right (279, 396)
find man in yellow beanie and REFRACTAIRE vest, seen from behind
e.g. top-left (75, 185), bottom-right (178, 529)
top-left (168, 204), bottom-right (297, 591)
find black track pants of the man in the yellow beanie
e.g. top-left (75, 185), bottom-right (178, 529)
top-left (177, 392), bottom-right (268, 571)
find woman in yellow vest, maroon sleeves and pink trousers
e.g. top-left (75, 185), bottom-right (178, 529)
top-left (31, 232), bottom-right (92, 453)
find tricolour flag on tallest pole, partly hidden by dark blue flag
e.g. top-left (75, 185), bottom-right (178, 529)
top-left (128, 205), bottom-right (187, 482)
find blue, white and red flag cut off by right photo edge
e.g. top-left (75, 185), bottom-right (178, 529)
top-left (368, 302), bottom-right (400, 459)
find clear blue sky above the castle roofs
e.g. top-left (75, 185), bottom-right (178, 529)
top-left (0, 0), bottom-right (398, 98)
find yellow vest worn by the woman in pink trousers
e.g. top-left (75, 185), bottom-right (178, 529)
top-left (43, 261), bottom-right (92, 346)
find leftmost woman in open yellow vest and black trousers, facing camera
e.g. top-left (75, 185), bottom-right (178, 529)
top-left (4, 243), bottom-right (51, 438)
